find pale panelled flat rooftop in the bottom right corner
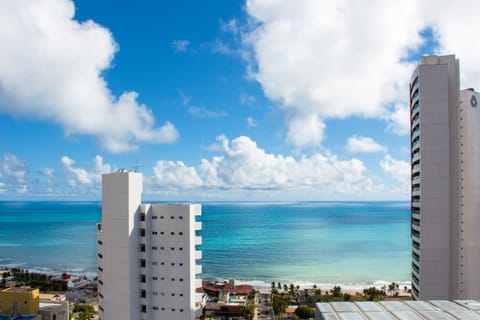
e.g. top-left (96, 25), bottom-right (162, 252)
top-left (315, 300), bottom-right (480, 320)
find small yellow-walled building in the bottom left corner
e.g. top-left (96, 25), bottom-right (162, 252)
top-left (0, 288), bottom-right (40, 315)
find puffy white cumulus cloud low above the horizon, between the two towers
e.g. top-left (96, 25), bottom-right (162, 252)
top-left (149, 135), bottom-right (371, 196)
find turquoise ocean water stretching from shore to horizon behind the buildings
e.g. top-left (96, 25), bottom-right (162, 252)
top-left (0, 202), bottom-right (410, 283)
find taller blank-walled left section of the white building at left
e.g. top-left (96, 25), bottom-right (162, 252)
top-left (99, 172), bottom-right (142, 320)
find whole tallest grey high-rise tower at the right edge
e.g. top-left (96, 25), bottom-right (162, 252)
top-left (410, 55), bottom-right (480, 300)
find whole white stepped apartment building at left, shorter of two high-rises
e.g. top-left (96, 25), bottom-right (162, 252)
top-left (97, 170), bottom-right (202, 320)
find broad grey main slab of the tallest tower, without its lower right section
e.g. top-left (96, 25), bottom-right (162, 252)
top-left (412, 56), bottom-right (458, 299)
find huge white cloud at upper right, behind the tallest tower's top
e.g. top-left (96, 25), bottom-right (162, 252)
top-left (243, 0), bottom-right (480, 146)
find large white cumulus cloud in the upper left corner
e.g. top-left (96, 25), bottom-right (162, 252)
top-left (0, 0), bottom-right (178, 152)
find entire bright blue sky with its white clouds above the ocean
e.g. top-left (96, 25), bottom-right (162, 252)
top-left (0, 0), bottom-right (480, 201)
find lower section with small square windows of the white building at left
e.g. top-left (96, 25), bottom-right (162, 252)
top-left (143, 204), bottom-right (201, 320)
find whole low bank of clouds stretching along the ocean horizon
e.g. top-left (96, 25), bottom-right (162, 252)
top-left (0, 135), bottom-right (410, 201)
